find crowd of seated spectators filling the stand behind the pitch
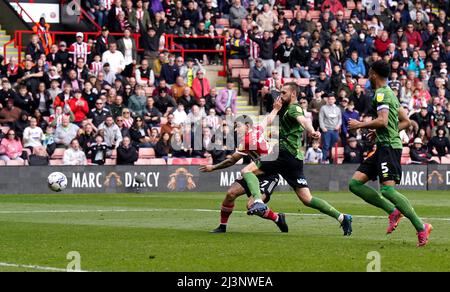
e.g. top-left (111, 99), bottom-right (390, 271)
top-left (0, 0), bottom-right (450, 165)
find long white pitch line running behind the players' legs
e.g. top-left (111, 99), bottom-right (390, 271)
top-left (0, 208), bottom-right (450, 221)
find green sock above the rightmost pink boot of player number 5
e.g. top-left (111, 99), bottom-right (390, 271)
top-left (381, 186), bottom-right (425, 231)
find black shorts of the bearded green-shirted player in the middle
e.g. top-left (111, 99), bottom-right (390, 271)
top-left (258, 149), bottom-right (308, 189)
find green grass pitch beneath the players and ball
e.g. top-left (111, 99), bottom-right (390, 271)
top-left (0, 191), bottom-right (450, 271)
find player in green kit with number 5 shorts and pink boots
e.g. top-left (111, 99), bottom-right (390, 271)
top-left (349, 61), bottom-right (433, 246)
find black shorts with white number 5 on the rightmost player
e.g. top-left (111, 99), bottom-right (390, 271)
top-left (358, 146), bottom-right (402, 184)
